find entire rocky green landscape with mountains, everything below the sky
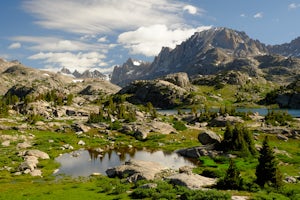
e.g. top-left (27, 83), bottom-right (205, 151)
top-left (0, 28), bottom-right (300, 200)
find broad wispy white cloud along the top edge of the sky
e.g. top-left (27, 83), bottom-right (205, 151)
top-left (23, 0), bottom-right (190, 34)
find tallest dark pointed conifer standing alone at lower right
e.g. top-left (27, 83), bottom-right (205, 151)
top-left (255, 136), bottom-right (282, 188)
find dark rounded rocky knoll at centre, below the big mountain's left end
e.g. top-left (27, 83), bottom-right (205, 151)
top-left (119, 80), bottom-right (188, 109)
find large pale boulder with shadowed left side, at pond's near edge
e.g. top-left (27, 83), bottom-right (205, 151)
top-left (106, 159), bottom-right (167, 182)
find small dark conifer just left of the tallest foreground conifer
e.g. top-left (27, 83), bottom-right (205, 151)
top-left (217, 159), bottom-right (243, 190)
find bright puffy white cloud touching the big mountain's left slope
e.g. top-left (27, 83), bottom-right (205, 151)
top-left (118, 24), bottom-right (210, 56)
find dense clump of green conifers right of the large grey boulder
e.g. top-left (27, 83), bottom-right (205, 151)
top-left (220, 124), bottom-right (256, 156)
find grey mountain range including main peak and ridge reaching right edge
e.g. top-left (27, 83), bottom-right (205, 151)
top-left (111, 28), bottom-right (300, 86)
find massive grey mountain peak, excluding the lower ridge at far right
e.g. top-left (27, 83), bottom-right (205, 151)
top-left (111, 28), bottom-right (268, 85)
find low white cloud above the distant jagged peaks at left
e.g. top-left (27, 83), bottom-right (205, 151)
top-left (28, 52), bottom-right (106, 72)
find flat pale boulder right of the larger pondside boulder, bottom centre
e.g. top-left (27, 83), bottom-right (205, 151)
top-left (166, 173), bottom-right (217, 190)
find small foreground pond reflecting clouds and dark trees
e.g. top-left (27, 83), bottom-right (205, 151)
top-left (55, 148), bottom-right (196, 177)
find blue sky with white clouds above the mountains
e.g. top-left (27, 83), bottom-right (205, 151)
top-left (0, 0), bottom-right (300, 74)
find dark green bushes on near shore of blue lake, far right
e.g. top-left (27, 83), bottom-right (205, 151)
top-left (265, 110), bottom-right (293, 126)
